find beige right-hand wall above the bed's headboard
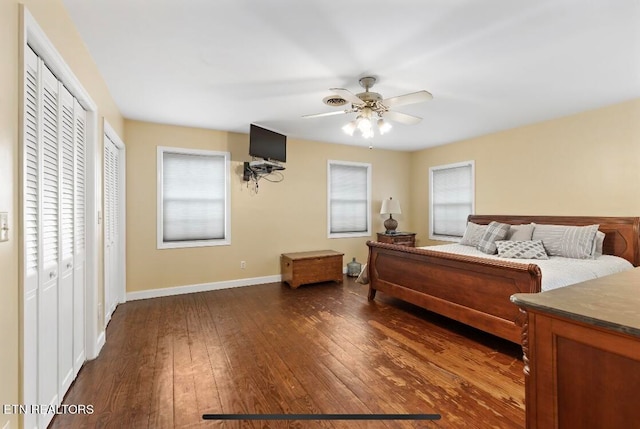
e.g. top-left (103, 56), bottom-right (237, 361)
top-left (411, 99), bottom-right (640, 245)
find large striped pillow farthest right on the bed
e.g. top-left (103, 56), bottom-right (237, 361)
top-left (531, 224), bottom-right (599, 259)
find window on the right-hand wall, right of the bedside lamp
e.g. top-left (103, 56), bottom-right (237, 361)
top-left (429, 161), bottom-right (475, 241)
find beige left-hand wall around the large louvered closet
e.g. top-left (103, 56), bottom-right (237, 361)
top-left (0, 0), bottom-right (123, 428)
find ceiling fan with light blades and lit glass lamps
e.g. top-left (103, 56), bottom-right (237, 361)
top-left (303, 76), bottom-right (433, 138)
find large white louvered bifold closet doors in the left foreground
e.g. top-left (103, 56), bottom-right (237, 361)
top-left (23, 49), bottom-right (86, 427)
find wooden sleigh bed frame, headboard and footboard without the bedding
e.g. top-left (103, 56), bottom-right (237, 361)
top-left (367, 215), bottom-right (640, 343)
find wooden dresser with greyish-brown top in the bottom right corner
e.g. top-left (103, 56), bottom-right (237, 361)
top-left (511, 268), bottom-right (640, 429)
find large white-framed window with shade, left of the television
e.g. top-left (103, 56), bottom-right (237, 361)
top-left (158, 147), bottom-right (230, 249)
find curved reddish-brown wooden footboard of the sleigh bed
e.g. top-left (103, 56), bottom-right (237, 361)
top-left (367, 241), bottom-right (542, 343)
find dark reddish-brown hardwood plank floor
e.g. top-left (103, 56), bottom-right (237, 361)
top-left (50, 277), bottom-right (524, 429)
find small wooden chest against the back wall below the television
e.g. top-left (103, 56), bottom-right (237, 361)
top-left (280, 250), bottom-right (344, 289)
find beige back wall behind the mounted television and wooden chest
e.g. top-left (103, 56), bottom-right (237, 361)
top-left (124, 121), bottom-right (411, 292)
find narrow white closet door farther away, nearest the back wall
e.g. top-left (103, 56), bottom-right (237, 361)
top-left (104, 134), bottom-right (121, 324)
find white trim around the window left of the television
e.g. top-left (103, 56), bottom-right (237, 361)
top-left (156, 146), bottom-right (231, 249)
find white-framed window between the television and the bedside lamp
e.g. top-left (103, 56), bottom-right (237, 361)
top-left (327, 161), bottom-right (371, 238)
